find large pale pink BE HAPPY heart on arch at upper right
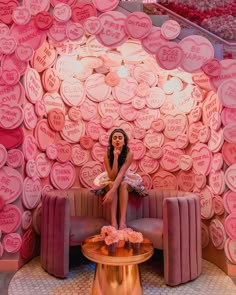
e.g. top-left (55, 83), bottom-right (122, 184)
top-left (179, 35), bottom-right (214, 73)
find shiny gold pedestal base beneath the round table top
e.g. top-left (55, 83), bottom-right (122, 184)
top-left (92, 263), bottom-right (143, 295)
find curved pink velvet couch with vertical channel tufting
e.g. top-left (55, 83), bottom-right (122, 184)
top-left (41, 188), bottom-right (201, 286)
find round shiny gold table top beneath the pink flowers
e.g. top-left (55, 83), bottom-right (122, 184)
top-left (81, 237), bottom-right (154, 265)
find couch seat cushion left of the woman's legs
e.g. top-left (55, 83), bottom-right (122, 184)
top-left (70, 216), bottom-right (109, 246)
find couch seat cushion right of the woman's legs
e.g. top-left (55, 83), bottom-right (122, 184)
top-left (127, 218), bottom-right (163, 249)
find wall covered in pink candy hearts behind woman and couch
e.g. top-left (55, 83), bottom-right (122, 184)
top-left (0, 0), bottom-right (236, 271)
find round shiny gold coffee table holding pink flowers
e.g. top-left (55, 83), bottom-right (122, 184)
top-left (81, 237), bottom-right (154, 295)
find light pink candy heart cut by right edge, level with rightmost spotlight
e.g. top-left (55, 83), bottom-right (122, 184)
top-left (217, 79), bottom-right (236, 109)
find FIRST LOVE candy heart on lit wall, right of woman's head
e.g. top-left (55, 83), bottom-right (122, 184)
top-left (164, 114), bottom-right (188, 139)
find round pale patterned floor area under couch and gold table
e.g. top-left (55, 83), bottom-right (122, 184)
top-left (8, 257), bottom-right (236, 295)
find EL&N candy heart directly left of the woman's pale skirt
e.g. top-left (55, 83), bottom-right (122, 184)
top-left (80, 161), bottom-right (104, 188)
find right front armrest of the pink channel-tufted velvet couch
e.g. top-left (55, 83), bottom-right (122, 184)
top-left (163, 194), bottom-right (201, 286)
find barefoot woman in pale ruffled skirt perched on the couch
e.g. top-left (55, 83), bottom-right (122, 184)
top-left (94, 129), bottom-right (146, 229)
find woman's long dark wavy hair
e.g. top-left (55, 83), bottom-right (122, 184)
top-left (107, 129), bottom-right (129, 170)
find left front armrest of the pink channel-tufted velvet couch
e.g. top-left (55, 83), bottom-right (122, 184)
top-left (41, 194), bottom-right (70, 278)
